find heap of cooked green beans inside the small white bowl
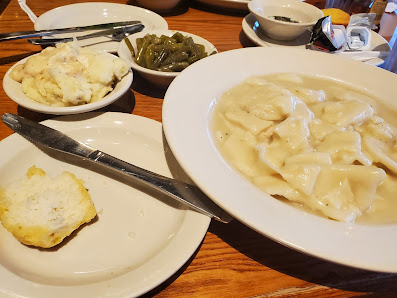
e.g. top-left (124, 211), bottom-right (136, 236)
top-left (126, 32), bottom-right (216, 72)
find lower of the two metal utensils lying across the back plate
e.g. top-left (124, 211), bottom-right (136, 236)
top-left (28, 24), bottom-right (145, 46)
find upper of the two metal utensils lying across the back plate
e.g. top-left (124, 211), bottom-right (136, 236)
top-left (0, 21), bottom-right (141, 41)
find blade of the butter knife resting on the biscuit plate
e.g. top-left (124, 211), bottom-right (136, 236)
top-left (88, 150), bottom-right (232, 223)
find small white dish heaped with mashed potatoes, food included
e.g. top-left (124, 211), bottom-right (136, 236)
top-left (3, 42), bottom-right (133, 115)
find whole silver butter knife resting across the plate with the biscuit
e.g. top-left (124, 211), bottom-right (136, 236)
top-left (1, 113), bottom-right (232, 223)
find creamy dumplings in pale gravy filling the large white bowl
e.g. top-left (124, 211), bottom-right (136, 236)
top-left (214, 74), bottom-right (397, 222)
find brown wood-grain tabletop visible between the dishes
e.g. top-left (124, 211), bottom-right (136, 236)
top-left (0, 0), bottom-right (397, 297)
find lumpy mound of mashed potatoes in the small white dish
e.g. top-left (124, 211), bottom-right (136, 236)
top-left (10, 42), bottom-right (129, 107)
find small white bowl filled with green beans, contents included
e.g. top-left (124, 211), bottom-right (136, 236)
top-left (117, 30), bottom-right (217, 87)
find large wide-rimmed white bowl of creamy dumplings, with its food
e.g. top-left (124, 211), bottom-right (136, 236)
top-left (162, 47), bottom-right (397, 273)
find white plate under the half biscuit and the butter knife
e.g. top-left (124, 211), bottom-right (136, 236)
top-left (0, 113), bottom-right (210, 298)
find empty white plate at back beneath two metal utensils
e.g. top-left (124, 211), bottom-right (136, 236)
top-left (34, 2), bottom-right (168, 53)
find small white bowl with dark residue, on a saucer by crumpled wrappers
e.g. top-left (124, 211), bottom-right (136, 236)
top-left (248, 0), bottom-right (324, 40)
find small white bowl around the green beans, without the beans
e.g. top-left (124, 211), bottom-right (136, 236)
top-left (117, 30), bottom-right (218, 87)
